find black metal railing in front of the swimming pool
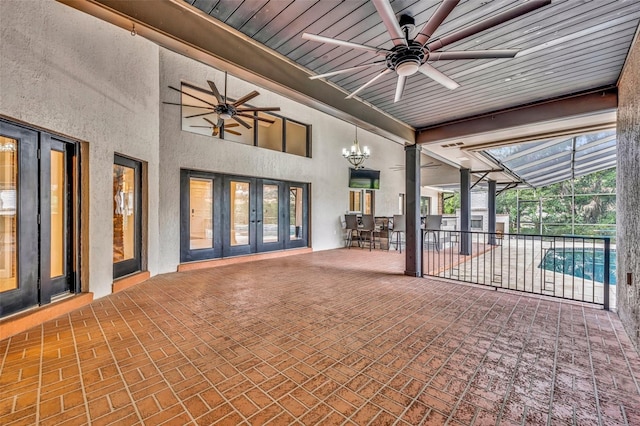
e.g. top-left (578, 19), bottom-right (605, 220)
top-left (422, 230), bottom-right (616, 310)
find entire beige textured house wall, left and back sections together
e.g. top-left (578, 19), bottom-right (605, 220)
top-left (0, 0), bottom-right (404, 297)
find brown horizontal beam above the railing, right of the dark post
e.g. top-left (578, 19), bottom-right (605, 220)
top-left (416, 88), bottom-right (618, 144)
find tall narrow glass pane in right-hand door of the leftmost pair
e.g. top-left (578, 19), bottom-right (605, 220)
top-left (51, 150), bottom-right (66, 278)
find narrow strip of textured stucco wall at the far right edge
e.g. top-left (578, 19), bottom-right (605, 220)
top-left (616, 40), bottom-right (640, 351)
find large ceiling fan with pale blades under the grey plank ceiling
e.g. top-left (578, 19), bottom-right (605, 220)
top-left (302, 0), bottom-right (551, 102)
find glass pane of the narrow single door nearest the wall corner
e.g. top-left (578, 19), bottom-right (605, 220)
top-left (113, 164), bottom-right (138, 262)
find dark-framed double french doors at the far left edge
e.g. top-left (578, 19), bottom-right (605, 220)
top-left (0, 120), bottom-right (79, 317)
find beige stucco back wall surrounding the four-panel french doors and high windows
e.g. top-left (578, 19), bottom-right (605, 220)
top-left (159, 49), bottom-right (404, 272)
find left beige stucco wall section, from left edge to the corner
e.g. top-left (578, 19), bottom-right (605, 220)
top-left (0, 0), bottom-right (159, 297)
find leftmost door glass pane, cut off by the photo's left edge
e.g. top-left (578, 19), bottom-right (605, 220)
top-left (0, 136), bottom-right (18, 293)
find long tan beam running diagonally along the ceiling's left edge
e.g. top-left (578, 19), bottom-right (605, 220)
top-left (58, 0), bottom-right (416, 144)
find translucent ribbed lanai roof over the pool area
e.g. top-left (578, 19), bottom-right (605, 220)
top-left (483, 129), bottom-right (616, 188)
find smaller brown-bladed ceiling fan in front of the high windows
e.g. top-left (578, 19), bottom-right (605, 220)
top-left (164, 72), bottom-right (280, 129)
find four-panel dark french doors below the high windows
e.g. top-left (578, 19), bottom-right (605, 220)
top-left (181, 170), bottom-right (308, 262)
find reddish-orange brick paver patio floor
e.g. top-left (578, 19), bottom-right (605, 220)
top-left (0, 249), bottom-right (640, 425)
